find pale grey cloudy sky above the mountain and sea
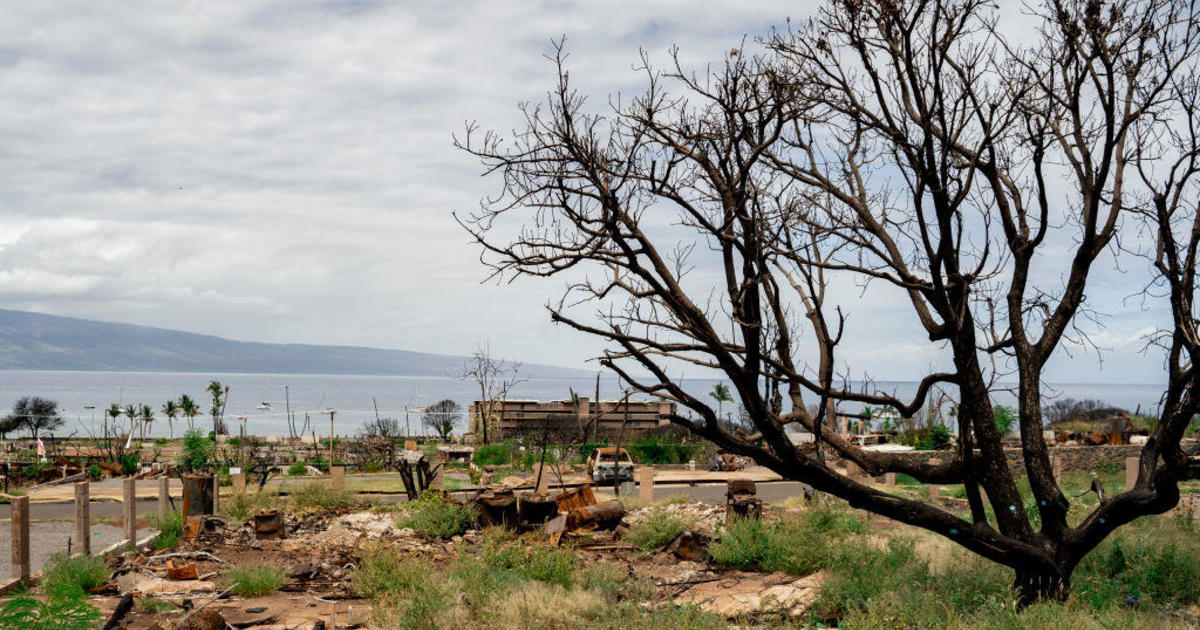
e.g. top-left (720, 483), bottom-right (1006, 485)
top-left (0, 0), bottom-right (1160, 383)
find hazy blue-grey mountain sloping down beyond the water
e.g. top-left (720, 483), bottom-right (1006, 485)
top-left (0, 310), bottom-right (590, 378)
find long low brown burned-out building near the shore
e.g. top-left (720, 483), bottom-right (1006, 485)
top-left (468, 398), bottom-right (676, 439)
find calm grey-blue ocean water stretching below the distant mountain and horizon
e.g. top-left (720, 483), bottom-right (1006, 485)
top-left (0, 370), bottom-right (1163, 437)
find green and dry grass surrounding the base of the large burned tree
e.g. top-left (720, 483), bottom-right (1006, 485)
top-left (709, 496), bottom-right (1200, 630)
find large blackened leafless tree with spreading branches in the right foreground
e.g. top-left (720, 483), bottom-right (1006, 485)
top-left (456, 0), bottom-right (1200, 604)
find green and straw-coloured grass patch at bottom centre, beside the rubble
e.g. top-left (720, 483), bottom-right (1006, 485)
top-left (352, 530), bottom-right (726, 630)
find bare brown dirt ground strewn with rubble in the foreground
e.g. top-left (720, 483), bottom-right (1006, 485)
top-left (94, 494), bottom-right (823, 630)
